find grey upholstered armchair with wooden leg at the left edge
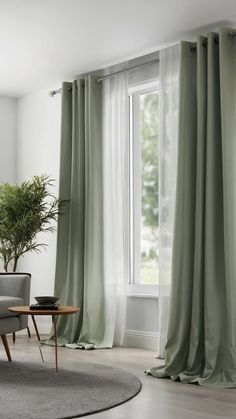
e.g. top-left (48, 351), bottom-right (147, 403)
top-left (0, 273), bottom-right (31, 361)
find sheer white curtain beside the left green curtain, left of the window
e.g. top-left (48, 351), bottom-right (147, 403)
top-left (103, 73), bottom-right (129, 346)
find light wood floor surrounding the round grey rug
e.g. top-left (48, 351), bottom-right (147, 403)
top-left (0, 332), bottom-right (236, 419)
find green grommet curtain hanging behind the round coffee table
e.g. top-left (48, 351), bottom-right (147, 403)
top-left (47, 76), bottom-right (108, 349)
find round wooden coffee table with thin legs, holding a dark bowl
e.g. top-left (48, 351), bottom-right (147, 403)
top-left (8, 306), bottom-right (80, 372)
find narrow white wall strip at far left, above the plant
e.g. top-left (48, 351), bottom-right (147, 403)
top-left (0, 97), bottom-right (16, 183)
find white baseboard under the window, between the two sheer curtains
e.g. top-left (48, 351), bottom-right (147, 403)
top-left (125, 329), bottom-right (159, 351)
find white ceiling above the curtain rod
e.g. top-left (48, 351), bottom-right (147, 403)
top-left (0, 0), bottom-right (236, 97)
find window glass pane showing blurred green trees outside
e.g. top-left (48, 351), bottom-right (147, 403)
top-left (140, 92), bottom-right (159, 284)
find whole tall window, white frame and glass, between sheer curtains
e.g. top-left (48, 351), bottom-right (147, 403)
top-left (129, 82), bottom-right (159, 294)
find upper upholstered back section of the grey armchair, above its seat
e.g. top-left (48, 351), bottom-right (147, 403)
top-left (0, 273), bottom-right (31, 305)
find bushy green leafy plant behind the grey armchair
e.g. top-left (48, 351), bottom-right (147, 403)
top-left (0, 175), bottom-right (62, 272)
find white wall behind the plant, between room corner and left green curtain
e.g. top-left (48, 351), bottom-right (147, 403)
top-left (16, 86), bottom-right (61, 302)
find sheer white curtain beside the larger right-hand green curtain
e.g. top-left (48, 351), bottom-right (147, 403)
top-left (158, 44), bottom-right (180, 358)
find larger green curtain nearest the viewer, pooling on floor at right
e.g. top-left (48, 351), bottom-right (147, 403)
top-left (148, 29), bottom-right (236, 387)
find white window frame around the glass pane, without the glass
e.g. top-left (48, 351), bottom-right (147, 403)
top-left (127, 80), bottom-right (159, 298)
